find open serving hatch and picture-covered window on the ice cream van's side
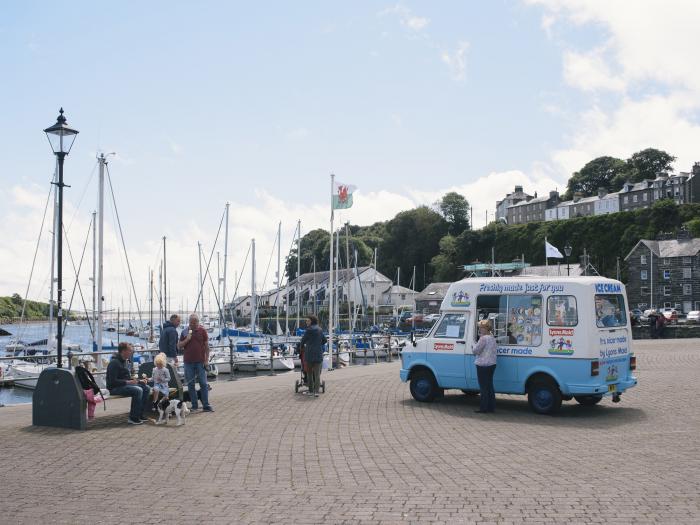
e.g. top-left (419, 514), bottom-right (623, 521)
top-left (475, 295), bottom-right (542, 346)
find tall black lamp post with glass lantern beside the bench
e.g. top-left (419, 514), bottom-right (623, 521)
top-left (44, 108), bottom-right (78, 368)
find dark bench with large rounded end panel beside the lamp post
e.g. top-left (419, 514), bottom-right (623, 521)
top-left (32, 363), bottom-right (184, 430)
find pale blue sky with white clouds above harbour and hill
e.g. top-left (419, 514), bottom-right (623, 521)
top-left (0, 0), bottom-right (700, 310)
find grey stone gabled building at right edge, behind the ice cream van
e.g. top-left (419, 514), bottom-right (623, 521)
top-left (625, 231), bottom-right (700, 313)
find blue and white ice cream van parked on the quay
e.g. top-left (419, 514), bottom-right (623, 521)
top-left (401, 276), bottom-right (637, 414)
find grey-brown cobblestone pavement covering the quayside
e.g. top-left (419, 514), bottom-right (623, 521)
top-left (0, 339), bottom-right (700, 524)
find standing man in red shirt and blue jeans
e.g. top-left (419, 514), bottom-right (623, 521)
top-left (177, 314), bottom-right (214, 412)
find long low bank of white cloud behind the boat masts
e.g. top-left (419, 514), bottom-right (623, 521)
top-left (0, 171), bottom-right (556, 304)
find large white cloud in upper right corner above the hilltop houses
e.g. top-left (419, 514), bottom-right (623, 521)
top-left (525, 0), bottom-right (700, 174)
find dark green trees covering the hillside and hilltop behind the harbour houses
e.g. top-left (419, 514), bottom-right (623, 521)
top-left (286, 148), bottom-right (700, 290)
